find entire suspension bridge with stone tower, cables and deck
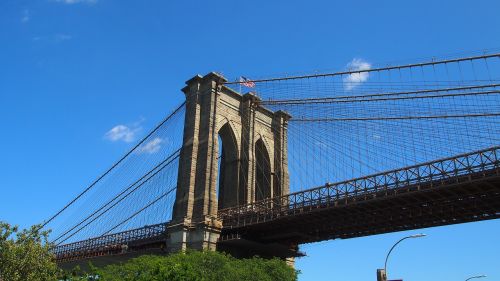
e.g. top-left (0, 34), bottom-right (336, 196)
top-left (43, 53), bottom-right (500, 267)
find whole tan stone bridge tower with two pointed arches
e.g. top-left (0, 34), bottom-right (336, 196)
top-left (168, 73), bottom-right (290, 251)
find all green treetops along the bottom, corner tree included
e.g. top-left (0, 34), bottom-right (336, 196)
top-left (0, 222), bottom-right (298, 281)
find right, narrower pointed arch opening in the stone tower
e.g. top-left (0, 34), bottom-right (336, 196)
top-left (255, 139), bottom-right (272, 200)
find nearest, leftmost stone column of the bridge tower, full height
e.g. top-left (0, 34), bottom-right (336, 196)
top-left (167, 73), bottom-right (226, 252)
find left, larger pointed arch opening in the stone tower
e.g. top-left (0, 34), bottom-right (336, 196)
top-left (216, 123), bottom-right (240, 209)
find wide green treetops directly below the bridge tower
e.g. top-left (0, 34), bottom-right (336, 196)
top-left (68, 251), bottom-right (297, 281)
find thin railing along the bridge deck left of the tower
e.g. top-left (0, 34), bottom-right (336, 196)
top-left (52, 223), bottom-right (168, 259)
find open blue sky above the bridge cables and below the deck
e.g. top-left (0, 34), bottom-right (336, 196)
top-left (0, 0), bottom-right (500, 281)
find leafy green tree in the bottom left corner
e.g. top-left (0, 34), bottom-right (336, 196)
top-left (0, 221), bottom-right (58, 281)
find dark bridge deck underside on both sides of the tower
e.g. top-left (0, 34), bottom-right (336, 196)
top-left (58, 168), bottom-right (500, 269)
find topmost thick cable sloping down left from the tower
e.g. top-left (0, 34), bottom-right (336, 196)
top-left (40, 102), bottom-right (186, 229)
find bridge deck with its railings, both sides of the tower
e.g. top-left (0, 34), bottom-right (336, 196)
top-left (54, 147), bottom-right (500, 263)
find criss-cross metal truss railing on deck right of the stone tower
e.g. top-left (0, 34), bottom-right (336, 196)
top-left (218, 146), bottom-right (500, 228)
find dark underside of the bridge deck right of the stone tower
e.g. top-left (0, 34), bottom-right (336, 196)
top-left (219, 169), bottom-right (500, 250)
